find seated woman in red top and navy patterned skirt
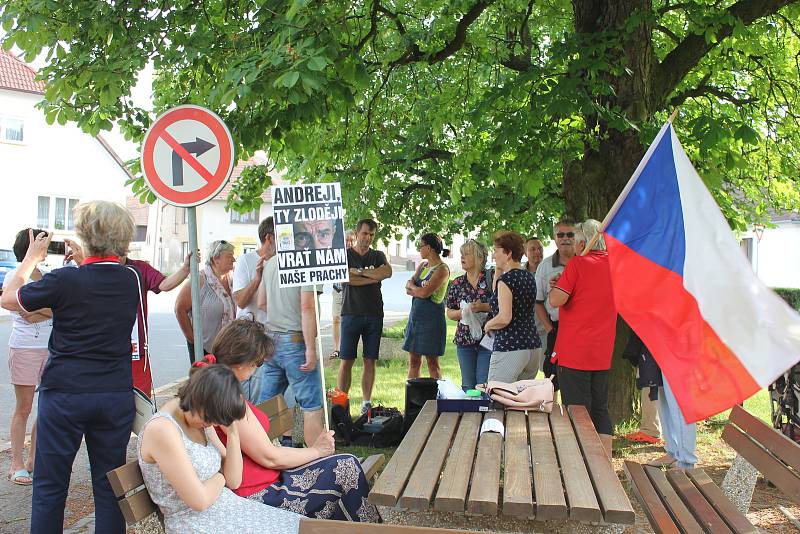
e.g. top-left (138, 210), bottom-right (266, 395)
top-left (206, 319), bottom-right (381, 523)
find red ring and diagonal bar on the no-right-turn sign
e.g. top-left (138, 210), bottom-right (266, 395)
top-left (142, 105), bottom-right (233, 207)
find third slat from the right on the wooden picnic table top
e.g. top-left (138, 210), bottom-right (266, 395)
top-left (528, 412), bottom-right (567, 521)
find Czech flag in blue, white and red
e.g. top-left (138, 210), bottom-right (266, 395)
top-left (604, 122), bottom-right (800, 423)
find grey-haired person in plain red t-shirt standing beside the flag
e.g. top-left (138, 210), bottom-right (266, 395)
top-left (549, 219), bottom-right (617, 456)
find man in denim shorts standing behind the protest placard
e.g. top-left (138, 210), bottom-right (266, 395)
top-left (257, 256), bottom-right (323, 446)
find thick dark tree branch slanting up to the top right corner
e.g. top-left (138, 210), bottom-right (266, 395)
top-left (653, 0), bottom-right (798, 105)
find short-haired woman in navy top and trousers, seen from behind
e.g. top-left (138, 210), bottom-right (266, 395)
top-left (0, 201), bottom-right (139, 533)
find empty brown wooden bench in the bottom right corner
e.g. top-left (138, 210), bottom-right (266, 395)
top-left (625, 406), bottom-right (800, 534)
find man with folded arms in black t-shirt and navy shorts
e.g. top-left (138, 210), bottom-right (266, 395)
top-left (336, 219), bottom-right (392, 413)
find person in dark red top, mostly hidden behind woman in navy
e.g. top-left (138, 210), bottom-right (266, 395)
top-left (64, 239), bottom-right (192, 397)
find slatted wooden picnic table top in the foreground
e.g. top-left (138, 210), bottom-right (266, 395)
top-left (369, 400), bottom-right (634, 524)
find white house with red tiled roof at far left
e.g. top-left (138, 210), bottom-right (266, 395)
top-left (0, 50), bottom-right (150, 260)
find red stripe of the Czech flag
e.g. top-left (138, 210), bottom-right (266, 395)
top-left (604, 234), bottom-right (761, 423)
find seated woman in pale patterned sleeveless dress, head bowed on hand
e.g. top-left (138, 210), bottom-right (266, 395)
top-left (138, 365), bottom-right (301, 534)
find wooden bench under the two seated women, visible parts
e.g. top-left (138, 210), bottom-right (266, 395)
top-left (106, 395), bottom-right (385, 525)
